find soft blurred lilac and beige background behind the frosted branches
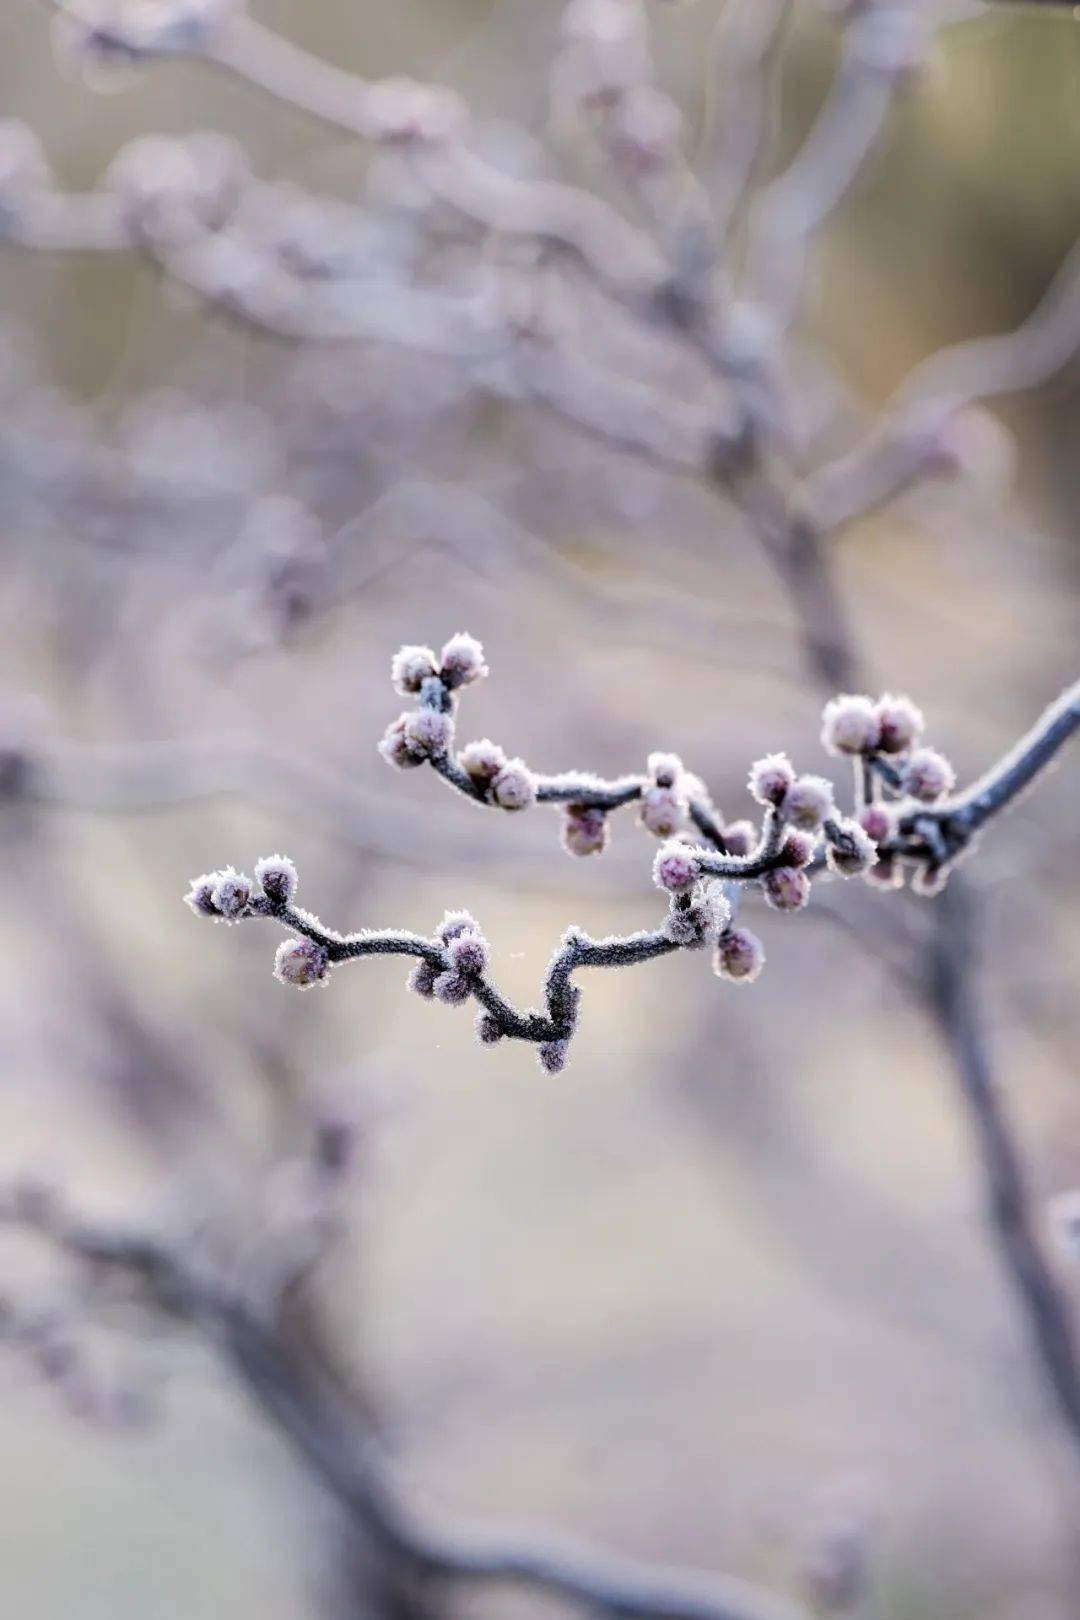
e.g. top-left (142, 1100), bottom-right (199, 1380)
top-left (0, 0), bottom-right (1080, 1620)
